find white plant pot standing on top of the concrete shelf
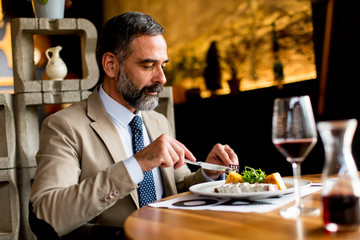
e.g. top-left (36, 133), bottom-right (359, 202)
top-left (31, 0), bottom-right (65, 19)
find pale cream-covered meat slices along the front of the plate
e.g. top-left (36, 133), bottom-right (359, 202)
top-left (214, 182), bottom-right (279, 193)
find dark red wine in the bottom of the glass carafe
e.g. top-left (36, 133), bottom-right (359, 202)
top-left (322, 195), bottom-right (360, 231)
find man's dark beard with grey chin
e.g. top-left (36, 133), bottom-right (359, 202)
top-left (117, 66), bottom-right (162, 111)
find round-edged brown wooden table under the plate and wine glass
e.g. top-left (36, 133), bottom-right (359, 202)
top-left (125, 174), bottom-right (360, 240)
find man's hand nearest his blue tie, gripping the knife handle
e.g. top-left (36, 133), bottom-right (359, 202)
top-left (134, 134), bottom-right (196, 172)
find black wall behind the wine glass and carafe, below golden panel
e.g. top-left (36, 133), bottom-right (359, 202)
top-left (175, 0), bottom-right (360, 175)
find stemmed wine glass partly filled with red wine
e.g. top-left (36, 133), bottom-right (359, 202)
top-left (272, 96), bottom-right (320, 218)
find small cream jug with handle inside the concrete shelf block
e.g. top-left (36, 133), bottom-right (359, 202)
top-left (45, 46), bottom-right (67, 80)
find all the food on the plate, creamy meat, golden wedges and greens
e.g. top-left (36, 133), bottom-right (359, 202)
top-left (214, 166), bottom-right (287, 193)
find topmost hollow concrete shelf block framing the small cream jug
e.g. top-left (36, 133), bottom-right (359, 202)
top-left (11, 18), bottom-right (99, 96)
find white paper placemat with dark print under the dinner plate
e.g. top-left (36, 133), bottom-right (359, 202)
top-left (149, 186), bottom-right (321, 213)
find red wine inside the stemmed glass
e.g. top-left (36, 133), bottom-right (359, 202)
top-left (274, 138), bottom-right (316, 162)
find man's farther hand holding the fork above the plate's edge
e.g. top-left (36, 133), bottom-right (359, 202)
top-left (204, 143), bottom-right (239, 180)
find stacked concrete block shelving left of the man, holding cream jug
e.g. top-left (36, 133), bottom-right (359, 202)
top-left (7, 18), bottom-right (99, 240)
